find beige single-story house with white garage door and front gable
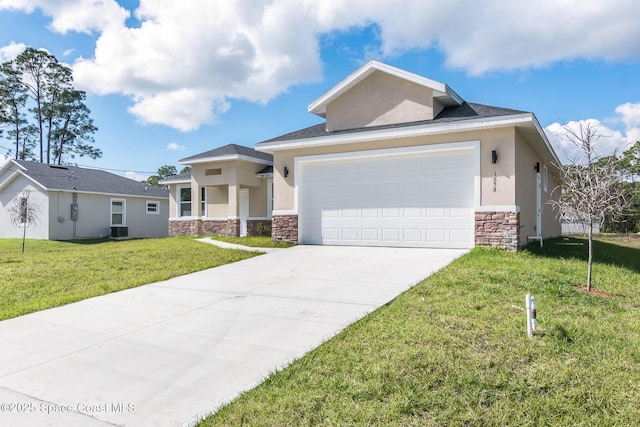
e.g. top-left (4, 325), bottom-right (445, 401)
top-left (164, 61), bottom-right (561, 249)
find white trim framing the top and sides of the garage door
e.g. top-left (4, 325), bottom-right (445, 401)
top-left (296, 140), bottom-right (481, 215)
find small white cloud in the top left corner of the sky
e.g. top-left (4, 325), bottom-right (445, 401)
top-left (0, 0), bottom-right (129, 34)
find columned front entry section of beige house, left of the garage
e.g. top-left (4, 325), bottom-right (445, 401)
top-left (159, 144), bottom-right (273, 236)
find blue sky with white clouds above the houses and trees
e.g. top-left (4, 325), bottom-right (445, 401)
top-left (0, 0), bottom-right (640, 178)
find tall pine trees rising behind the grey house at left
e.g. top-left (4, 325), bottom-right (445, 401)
top-left (0, 47), bottom-right (102, 164)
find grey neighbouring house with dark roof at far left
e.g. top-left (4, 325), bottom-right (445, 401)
top-left (0, 158), bottom-right (169, 240)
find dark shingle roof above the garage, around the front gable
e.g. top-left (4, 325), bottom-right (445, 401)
top-left (259, 102), bottom-right (528, 144)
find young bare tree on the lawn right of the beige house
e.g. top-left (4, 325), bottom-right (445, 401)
top-left (550, 124), bottom-right (626, 292)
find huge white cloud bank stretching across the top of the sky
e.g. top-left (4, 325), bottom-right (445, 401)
top-left (8, 0), bottom-right (640, 131)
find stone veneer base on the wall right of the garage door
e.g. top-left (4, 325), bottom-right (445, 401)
top-left (476, 212), bottom-right (520, 251)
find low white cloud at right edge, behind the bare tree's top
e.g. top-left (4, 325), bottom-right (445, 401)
top-left (545, 103), bottom-right (640, 163)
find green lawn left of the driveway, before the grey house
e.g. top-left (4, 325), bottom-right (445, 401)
top-left (0, 237), bottom-right (256, 320)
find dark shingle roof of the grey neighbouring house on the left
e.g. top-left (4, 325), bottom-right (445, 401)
top-left (14, 160), bottom-right (169, 197)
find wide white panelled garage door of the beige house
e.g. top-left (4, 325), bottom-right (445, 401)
top-left (299, 150), bottom-right (475, 248)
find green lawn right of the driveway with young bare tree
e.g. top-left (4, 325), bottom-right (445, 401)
top-left (200, 239), bottom-right (640, 426)
